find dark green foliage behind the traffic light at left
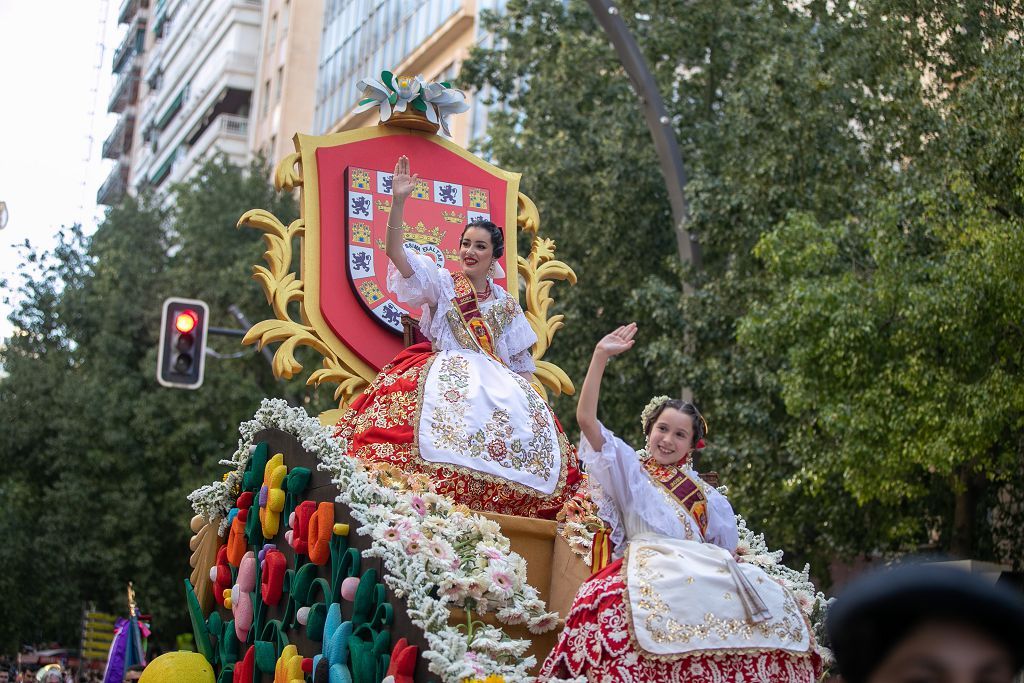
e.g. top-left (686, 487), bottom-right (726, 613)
top-left (0, 160), bottom-right (306, 651)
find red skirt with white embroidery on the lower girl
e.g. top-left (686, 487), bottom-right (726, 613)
top-left (538, 559), bottom-right (820, 683)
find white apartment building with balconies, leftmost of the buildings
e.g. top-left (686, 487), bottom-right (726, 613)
top-left (96, 0), bottom-right (262, 205)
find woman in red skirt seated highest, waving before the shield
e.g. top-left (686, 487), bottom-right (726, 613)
top-left (337, 157), bottom-right (580, 518)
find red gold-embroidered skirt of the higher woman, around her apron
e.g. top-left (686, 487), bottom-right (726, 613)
top-left (335, 343), bottom-right (581, 519)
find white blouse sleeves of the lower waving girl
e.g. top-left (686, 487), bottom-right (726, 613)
top-left (580, 425), bottom-right (739, 556)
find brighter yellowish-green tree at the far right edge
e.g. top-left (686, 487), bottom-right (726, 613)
top-left (740, 42), bottom-right (1024, 563)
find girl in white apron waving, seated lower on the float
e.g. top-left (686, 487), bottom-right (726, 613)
top-left (540, 324), bottom-right (820, 683)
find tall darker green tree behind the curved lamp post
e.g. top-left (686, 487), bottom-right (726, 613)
top-left (463, 0), bottom-right (1021, 581)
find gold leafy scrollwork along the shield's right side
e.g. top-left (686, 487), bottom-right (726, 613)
top-left (516, 193), bottom-right (577, 397)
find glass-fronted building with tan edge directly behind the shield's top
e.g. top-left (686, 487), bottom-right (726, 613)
top-left (313, 0), bottom-right (505, 146)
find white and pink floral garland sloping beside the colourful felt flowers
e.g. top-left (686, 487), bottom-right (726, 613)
top-left (188, 398), bottom-right (558, 683)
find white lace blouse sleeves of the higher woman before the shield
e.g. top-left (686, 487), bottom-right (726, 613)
top-left (387, 247), bottom-right (537, 373)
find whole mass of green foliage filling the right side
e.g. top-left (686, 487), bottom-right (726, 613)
top-left (463, 0), bottom-right (1024, 582)
